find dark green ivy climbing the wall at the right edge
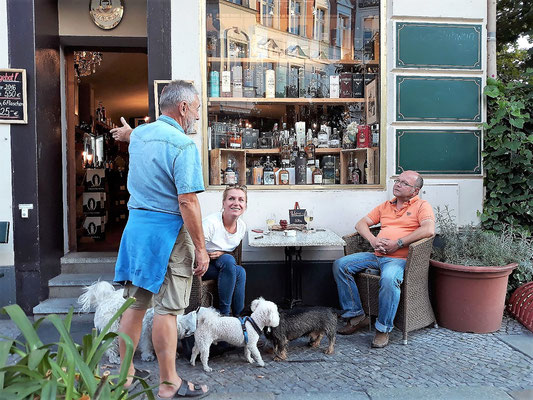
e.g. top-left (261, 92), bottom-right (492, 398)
top-left (479, 69), bottom-right (533, 236)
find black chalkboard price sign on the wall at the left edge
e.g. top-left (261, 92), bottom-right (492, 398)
top-left (0, 69), bottom-right (28, 124)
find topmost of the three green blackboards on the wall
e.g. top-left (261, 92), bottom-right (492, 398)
top-left (396, 22), bottom-right (481, 69)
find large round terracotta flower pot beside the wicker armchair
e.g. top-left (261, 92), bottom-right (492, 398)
top-left (429, 260), bottom-right (518, 333)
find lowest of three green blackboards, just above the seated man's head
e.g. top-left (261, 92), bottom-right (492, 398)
top-left (396, 129), bottom-right (481, 174)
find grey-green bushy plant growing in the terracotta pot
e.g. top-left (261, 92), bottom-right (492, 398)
top-left (432, 207), bottom-right (533, 291)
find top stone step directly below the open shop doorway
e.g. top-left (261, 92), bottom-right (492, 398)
top-left (61, 252), bottom-right (117, 274)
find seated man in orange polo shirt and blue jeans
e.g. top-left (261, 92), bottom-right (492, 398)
top-left (333, 171), bottom-right (435, 348)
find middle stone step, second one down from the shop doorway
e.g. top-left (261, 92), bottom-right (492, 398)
top-left (48, 273), bottom-right (119, 299)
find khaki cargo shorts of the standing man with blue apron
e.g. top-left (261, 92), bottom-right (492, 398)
top-left (124, 225), bottom-right (194, 315)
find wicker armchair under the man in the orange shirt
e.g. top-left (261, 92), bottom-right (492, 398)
top-left (343, 233), bottom-right (436, 344)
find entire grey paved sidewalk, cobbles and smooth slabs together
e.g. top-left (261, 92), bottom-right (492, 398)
top-left (0, 316), bottom-right (533, 400)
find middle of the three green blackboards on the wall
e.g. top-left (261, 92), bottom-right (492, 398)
top-left (396, 76), bottom-right (481, 122)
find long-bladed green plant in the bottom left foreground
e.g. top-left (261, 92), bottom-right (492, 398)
top-left (0, 299), bottom-right (154, 400)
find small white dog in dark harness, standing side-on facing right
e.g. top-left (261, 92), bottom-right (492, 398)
top-left (191, 297), bottom-right (279, 372)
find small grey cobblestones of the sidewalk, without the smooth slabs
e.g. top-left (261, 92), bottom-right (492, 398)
top-left (129, 317), bottom-right (533, 394)
